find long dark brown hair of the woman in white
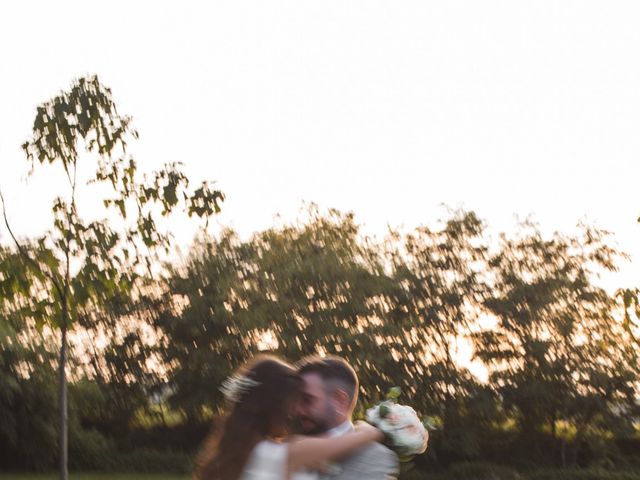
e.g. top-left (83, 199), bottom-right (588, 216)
top-left (193, 355), bottom-right (302, 480)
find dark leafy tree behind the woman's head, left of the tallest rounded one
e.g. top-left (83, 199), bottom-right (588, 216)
top-left (155, 230), bottom-right (260, 424)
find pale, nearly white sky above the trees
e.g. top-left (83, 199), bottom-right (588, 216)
top-left (0, 0), bottom-right (640, 286)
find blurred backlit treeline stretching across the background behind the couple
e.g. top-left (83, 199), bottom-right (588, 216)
top-left (0, 207), bottom-right (640, 478)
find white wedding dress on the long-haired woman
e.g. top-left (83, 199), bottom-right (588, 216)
top-left (240, 440), bottom-right (318, 480)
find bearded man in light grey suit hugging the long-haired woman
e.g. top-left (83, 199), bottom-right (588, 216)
top-left (298, 356), bottom-right (398, 480)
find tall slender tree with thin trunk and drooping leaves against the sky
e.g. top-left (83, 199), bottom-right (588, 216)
top-left (0, 76), bottom-right (224, 480)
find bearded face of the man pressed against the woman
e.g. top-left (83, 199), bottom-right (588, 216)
top-left (298, 372), bottom-right (335, 435)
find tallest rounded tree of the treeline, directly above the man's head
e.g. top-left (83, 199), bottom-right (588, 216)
top-left (251, 205), bottom-right (391, 382)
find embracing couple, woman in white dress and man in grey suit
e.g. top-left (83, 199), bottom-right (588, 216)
top-left (194, 356), bottom-right (398, 480)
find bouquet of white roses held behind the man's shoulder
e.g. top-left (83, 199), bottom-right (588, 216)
top-left (367, 387), bottom-right (433, 458)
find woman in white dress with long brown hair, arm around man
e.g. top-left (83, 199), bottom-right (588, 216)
top-left (193, 356), bottom-right (384, 480)
